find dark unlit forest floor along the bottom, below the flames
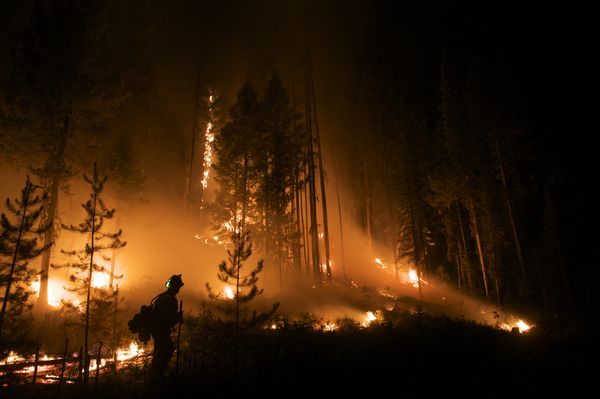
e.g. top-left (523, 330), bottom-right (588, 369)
top-left (0, 314), bottom-right (600, 399)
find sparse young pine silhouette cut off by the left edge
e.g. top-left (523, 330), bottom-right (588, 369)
top-left (0, 176), bottom-right (49, 337)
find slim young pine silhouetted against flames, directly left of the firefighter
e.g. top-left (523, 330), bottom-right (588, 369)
top-left (52, 163), bottom-right (126, 382)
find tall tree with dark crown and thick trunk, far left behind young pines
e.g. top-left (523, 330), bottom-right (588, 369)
top-left (0, 0), bottom-right (127, 306)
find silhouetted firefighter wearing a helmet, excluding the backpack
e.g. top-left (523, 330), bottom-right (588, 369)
top-left (150, 274), bottom-right (183, 381)
